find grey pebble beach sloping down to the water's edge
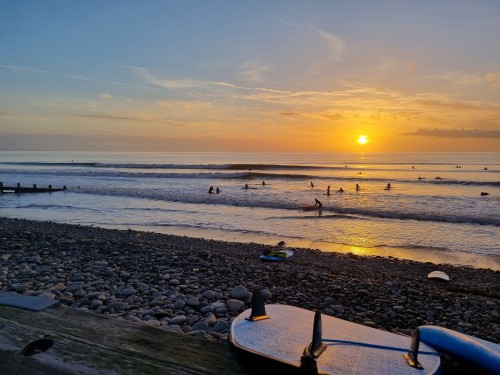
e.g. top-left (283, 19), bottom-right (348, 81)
top-left (0, 218), bottom-right (500, 350)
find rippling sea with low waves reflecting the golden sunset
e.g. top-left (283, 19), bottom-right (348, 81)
top-left (0, 151), bottom-right (500, 270)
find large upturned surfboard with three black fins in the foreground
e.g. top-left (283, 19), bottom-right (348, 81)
top-left (229, 300), bottom-right (441, 375)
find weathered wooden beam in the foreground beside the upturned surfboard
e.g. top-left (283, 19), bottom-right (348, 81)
top-left (0, 306), bottom-right (249, 375)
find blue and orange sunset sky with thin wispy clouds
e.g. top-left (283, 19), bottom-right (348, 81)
top-left (0, 0), bottom-right (500, 152)
